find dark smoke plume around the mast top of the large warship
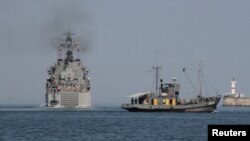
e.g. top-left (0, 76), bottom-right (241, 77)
top-left (41, 3), bottom-right (93, 52)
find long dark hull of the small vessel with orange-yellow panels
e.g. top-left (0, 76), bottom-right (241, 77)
top-left (121, 98), bottom-right (220, 113)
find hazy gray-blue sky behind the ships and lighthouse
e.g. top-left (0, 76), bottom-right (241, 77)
top-left (0, 0), bottom-right (250, 106)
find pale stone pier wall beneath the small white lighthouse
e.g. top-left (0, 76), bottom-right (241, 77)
top-left (223, 96), bottom-right (250, 106)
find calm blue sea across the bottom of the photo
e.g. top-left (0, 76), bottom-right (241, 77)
top-left (0, 105), bottom-right (250, 141)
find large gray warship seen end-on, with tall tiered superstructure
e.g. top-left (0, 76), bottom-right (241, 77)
top-left (45, 32), bottom-right (91, 108)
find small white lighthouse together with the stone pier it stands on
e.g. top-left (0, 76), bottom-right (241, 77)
top-left (223, 78), bottom-right (250, 106)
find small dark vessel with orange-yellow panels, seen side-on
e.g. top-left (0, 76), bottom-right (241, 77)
top-left (121, 67), bottom-right (221, 112)
